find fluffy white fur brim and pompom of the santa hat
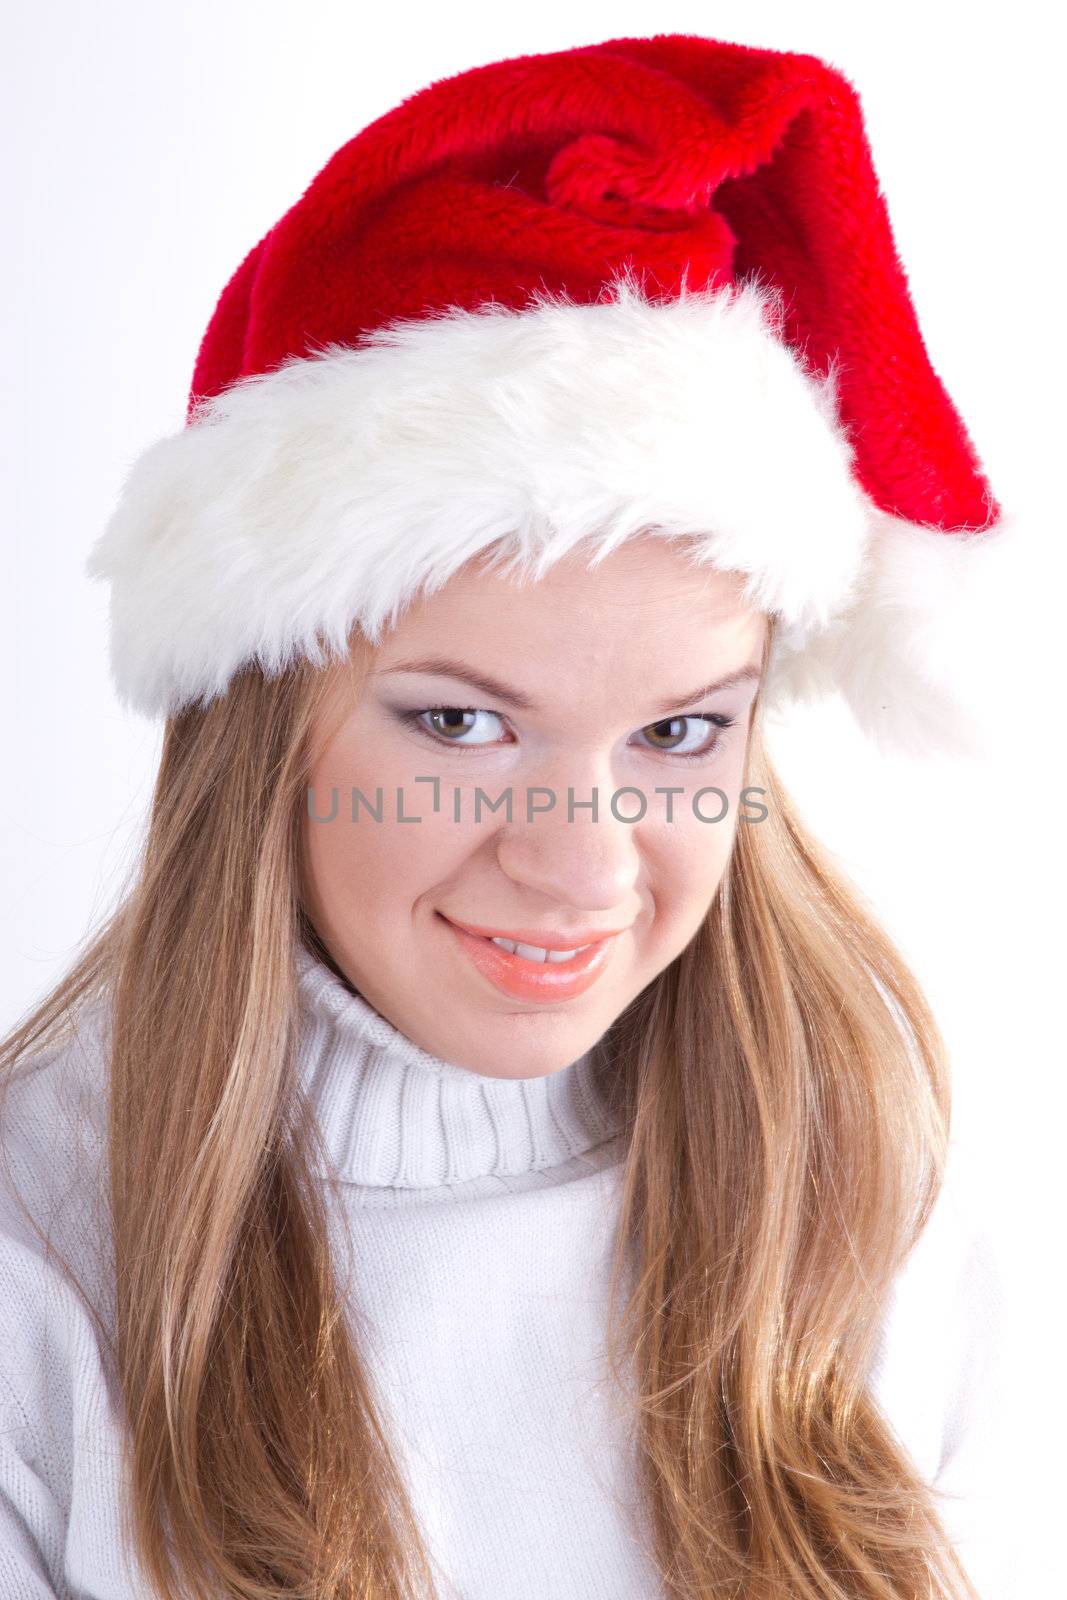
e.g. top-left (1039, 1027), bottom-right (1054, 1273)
top-left (88, 282), bottom-right (1011, 748)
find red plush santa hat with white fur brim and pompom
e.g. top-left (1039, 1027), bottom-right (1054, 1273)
top-left (88, 35), bottom-right (1009, 750)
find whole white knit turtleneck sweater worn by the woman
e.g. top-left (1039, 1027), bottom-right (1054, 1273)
top-left (0, 950), bottom-right (1008, 1600)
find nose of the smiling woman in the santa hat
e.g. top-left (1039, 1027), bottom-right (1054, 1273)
top-left (496, 784), bottom-right (640, 910)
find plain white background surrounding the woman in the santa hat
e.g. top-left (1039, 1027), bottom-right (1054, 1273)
top-left (0, 0), bottom-right (1067, 1600)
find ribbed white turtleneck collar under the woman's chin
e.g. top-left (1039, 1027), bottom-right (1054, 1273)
top-left (296, 942), bottom-right (619, 1189)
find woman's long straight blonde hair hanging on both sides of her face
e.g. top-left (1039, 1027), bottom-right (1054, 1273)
top-left (0, 617), bottom-right (977, 1600)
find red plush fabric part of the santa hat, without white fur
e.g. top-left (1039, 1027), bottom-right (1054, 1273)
top-left (187, 34), bottom-right (1000, 530)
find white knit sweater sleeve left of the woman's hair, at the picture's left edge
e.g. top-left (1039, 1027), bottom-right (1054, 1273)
top-left (0, 1000), bottom-right (132, 1595)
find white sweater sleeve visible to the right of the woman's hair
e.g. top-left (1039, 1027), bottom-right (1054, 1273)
top-left (875, 1157), bottom-right (1019, 1600)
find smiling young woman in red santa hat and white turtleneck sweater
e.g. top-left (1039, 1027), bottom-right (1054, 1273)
top-left (0, 35), bottom-right (1006, 1600)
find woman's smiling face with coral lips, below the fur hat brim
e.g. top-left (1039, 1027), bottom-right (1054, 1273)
top-left (304, 536), bottom-right (766, 1078)
